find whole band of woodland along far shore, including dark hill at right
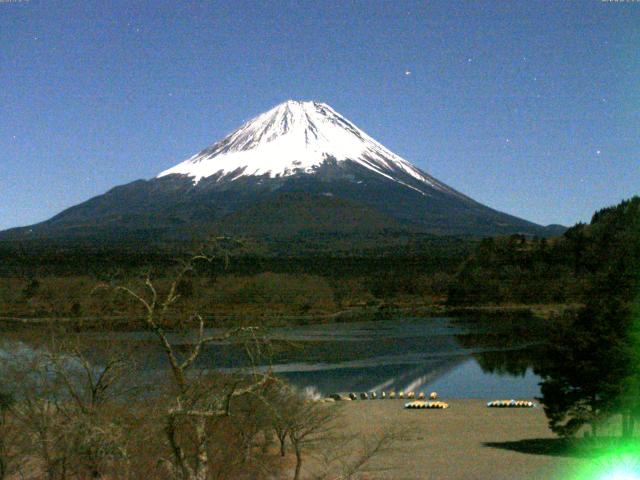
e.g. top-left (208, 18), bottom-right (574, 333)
top-left (0, 199), bottom-right (637, 316)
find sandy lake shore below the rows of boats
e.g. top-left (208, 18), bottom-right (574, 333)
top-left (340, 399), bottom-right (586, 480)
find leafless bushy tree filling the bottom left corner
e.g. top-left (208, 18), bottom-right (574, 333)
top-left (2, 332), bottom-right (138, 480)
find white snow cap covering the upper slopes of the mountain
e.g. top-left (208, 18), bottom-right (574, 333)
top-left (158, 100), bottom-right (462, 196)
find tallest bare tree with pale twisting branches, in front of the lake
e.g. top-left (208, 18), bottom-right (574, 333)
top-left (111, 243), bottom-right (273, 480)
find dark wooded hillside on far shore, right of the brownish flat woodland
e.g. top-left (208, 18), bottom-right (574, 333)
top-left (448, 221), bottom-right (620, 305)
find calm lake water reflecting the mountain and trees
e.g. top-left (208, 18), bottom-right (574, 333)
top-left (5, 318), bottom-right (540, 398)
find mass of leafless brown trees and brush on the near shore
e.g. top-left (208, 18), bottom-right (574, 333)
top-left (0, 254), bottom-right (391, 480)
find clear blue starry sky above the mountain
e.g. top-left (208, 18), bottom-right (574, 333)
top-left (0, 0), bottom-right (640, 229)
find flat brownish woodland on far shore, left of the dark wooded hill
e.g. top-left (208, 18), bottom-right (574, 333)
top-left (0, 234), bottom-right (474, 318)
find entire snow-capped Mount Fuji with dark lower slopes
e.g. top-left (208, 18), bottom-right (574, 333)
top-left (0, 100), bottom-right (558, 241)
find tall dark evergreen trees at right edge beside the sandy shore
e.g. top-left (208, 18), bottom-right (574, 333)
top-left (537, 197), bottom-right (640, 438)
